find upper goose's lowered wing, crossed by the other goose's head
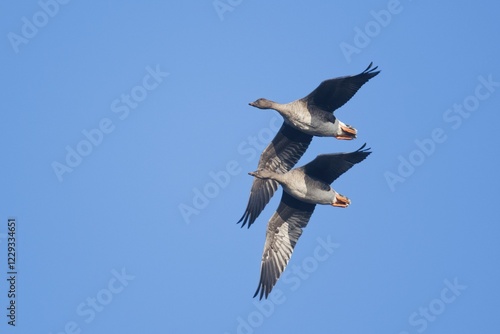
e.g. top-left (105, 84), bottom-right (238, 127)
top-left (238, 123), bottom-right (312, 227)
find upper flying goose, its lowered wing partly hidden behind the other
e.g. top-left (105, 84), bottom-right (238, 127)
top-left (238, 63), bottom-right (380, 228)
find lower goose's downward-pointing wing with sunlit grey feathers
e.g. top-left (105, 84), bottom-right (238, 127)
top-left (253, 191), bottom-right (316, 299)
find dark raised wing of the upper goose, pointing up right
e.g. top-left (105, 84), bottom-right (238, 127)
top-left (302, 63), bottom-right (380, 112)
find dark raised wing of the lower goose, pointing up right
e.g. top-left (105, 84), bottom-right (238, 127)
top-left (298, 143), bottom-right (371, 184)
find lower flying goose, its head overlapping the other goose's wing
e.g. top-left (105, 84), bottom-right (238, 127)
top-left (248, 144), bottom-right (371, 299)
